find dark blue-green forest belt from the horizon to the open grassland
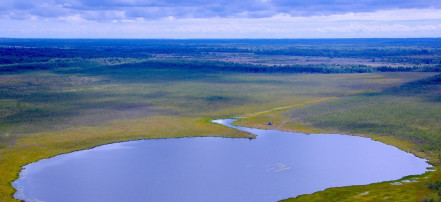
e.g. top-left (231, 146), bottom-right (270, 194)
top-left (0, 39), bottom-right (441, 73)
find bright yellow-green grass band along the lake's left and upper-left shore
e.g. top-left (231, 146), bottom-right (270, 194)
top-left (0, 117), bottom-right (254, 201)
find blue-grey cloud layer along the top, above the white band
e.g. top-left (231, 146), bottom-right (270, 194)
top-left (0, 0), bottom-right (441, 21)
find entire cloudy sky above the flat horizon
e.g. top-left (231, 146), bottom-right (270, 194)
top-left (0, 0), bottom-right (441, 39)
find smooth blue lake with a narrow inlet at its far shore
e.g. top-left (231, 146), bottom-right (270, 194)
top-left (13, 119), bottom-right (430, 202)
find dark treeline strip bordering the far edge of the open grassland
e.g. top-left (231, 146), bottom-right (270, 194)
top-left (0, 56), bottom-right (441, 74)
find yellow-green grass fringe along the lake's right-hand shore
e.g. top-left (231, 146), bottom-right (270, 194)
top-left (235, 104), bottom-right (441, 201)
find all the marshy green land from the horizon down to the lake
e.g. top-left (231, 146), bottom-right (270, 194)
top-left (0, 39), bottom-right (441, 201)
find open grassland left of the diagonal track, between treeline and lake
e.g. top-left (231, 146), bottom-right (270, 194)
top-left (0, 68), bottom-right (432, 201)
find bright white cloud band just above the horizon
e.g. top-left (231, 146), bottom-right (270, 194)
top-left (0, 9), bottom-right (441, 38)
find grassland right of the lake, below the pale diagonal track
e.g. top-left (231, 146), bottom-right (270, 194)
top-left (235, 75), bottom-right (441, 201)
